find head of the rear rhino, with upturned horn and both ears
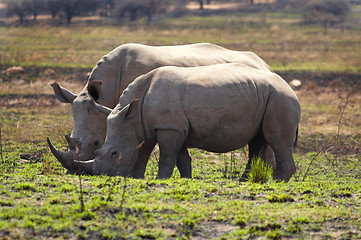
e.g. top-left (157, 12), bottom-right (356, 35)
top-left (48, 81), bottom-right (111, 167)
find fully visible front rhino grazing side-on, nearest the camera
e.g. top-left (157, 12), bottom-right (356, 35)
top-left (53, 64), bottom-right (300, 181)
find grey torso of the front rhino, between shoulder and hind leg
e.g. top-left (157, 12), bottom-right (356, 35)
top-left (142, 64), bottom-right (283, 152)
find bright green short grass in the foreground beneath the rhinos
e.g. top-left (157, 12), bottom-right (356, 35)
top-left (0, 146), bottom-right (361, 239)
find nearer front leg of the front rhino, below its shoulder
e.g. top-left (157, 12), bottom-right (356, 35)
top-left (156, 130), bottom-right (185, 178)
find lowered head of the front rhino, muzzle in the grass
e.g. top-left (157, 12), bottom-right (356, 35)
top-left (48, 99), bottom-right (141, 176)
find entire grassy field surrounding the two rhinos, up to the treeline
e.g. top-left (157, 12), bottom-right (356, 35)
top-left (0, 7), bottom-right (361, 239)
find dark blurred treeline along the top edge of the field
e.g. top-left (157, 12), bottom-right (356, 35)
top-left (0, 0), bottom-right (354, 31)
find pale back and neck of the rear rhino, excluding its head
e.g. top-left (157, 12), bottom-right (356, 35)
top-left (89, 43), bottom-right (271, 107)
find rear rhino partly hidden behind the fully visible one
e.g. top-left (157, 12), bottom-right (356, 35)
top-left (48, 43), bottom-right (272, 170)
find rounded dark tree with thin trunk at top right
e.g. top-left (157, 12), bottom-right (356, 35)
top-left (304, 0), bottom-right (350, 34)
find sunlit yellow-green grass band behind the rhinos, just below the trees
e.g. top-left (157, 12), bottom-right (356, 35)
top-left (0, 12), bottom-right (361, 72)
